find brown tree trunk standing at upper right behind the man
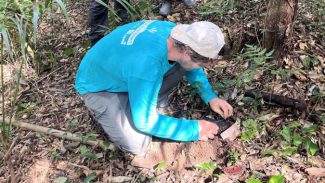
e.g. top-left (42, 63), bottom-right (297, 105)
top-left (263, 0), bottom-right (298, 60)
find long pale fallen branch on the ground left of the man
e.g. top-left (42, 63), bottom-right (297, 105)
top-left (0, 120), bottom-right (115, 150)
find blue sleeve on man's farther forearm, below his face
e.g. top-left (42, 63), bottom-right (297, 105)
top-left (185, 68), bottom-right (217, 104)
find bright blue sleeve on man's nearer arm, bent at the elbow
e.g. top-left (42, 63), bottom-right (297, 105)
top-left (128, 77), bottom-right (199, 141)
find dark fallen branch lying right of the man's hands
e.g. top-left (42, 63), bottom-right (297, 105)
top-left (245, 90), bottom-right (307, 111)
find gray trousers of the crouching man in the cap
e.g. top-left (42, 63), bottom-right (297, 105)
top-left (81, 64), bottom-right (185, 155)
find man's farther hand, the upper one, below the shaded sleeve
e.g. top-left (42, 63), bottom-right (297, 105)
top-left (209, 98), bottom-right (233, 119)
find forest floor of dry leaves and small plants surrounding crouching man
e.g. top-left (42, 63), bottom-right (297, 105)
top-left (0, 0), bottom-right (325, 182)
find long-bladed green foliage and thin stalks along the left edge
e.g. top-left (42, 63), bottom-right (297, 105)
top-left (0, 0), bottom-right (67, 150)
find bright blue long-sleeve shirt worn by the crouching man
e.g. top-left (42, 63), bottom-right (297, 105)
top-left (75, 20), bottom-right (216, 141)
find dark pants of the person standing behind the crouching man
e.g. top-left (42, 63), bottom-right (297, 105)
top-left (88, 0), bottom-right (127, 46)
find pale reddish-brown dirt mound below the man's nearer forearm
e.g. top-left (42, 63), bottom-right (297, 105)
top-left (132, 138), bottom-right (229, 170)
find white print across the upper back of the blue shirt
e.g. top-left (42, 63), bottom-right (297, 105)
top-left (121, 20), bottom-right (157, 45)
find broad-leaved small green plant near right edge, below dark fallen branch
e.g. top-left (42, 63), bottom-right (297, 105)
top-left (280, 121), bottom-right (318, 156)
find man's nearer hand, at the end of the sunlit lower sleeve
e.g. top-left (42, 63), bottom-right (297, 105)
top-left (199, 120), bottom-right (219, 141)
